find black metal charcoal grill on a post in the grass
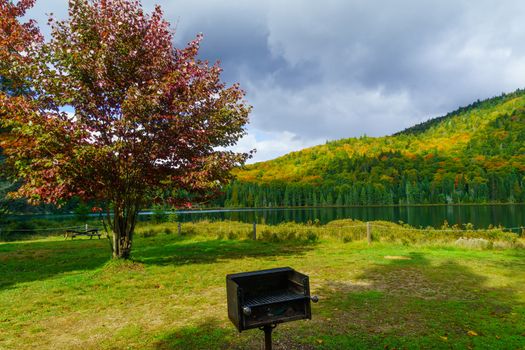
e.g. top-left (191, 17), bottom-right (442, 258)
top-left (226, 267), bottom-right (318, 349)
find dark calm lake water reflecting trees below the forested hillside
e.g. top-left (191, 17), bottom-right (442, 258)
top-left (5, 204), bottom-right (525, 228)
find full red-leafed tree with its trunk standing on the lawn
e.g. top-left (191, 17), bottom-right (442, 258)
top-left (3, 0), bottom-right (250, 258)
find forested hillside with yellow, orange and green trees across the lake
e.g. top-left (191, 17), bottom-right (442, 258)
top-left (214, 90), bottom-right (525, 207)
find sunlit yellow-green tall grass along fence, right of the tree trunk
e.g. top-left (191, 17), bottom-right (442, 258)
top-left (136, 219), bottom-right (524, 247)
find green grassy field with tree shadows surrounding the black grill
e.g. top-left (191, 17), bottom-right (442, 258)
top-left (0, 223), bottom-right (525, 349)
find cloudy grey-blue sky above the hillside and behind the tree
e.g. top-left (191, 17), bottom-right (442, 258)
top-left (29, 0), bottom-right (525, 162)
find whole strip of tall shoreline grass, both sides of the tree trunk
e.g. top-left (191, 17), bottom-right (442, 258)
top-left (0, 216), bottom-right (525, 248)
